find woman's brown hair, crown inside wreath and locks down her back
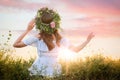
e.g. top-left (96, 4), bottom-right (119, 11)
top-left (40, 12), bottom-right (62, 50)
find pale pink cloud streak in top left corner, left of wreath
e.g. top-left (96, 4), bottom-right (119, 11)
top-left (0, 0), bottom-right (45, 10)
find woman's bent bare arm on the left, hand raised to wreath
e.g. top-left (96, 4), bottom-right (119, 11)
top-left (13, 19), bottom-right (35, 48)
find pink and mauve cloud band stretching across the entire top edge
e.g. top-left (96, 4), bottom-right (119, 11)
top-left (0, 0), bottom-right (120, 15)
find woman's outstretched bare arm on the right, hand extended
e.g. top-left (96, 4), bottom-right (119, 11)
top-left (70, 33), bottom-right (94, 52)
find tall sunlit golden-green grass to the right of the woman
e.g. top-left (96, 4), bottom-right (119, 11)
top-left (60, 55), bottom-right (120, 80)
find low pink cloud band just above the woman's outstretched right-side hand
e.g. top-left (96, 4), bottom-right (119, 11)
top-left (65, 27), bottom-right (120, 37)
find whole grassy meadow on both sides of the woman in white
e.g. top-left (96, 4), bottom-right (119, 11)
top-left (0, 33), bottom-right (120, 80)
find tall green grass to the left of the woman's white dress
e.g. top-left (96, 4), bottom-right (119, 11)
top-left (0, 52), bottom-right (31, 80)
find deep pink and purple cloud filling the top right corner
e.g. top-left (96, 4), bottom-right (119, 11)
top-left (62, 0), bottom-right (120, 16)
